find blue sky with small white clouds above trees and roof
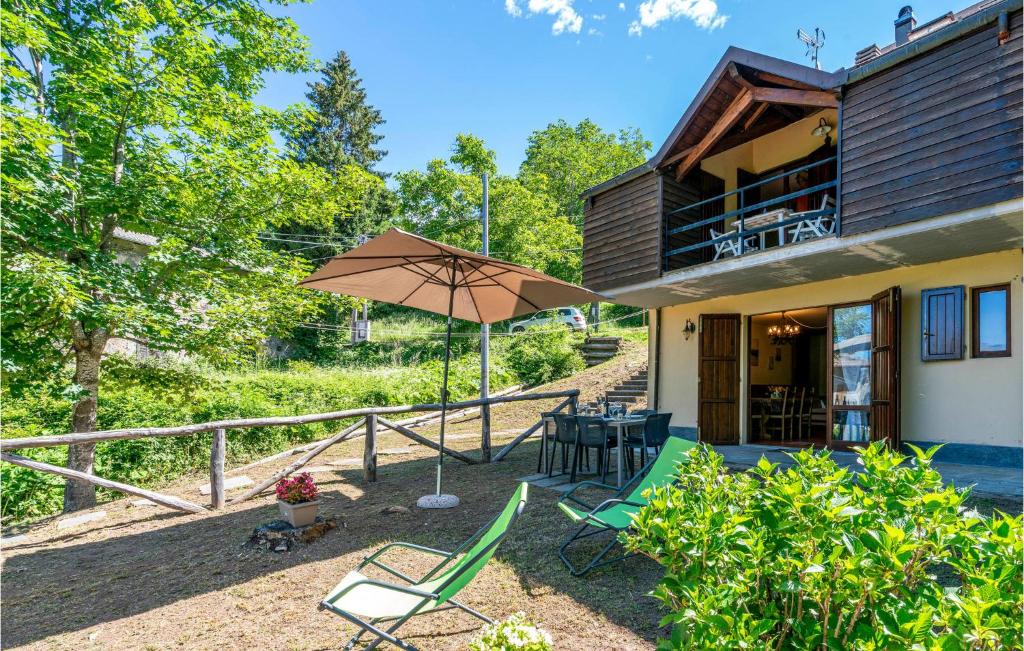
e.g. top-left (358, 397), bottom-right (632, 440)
top-left (261, 0), bottom-right (954, 173)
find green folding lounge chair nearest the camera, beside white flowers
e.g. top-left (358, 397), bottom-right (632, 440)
top-left (319, 483), bottom-right (526, 649)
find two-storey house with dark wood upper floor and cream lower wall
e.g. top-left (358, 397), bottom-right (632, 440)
top-left (584, 0), bottom-right (1024, 466)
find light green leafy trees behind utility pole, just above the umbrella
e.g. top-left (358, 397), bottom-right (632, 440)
top-left (395, 134), bottom-right (582, 281)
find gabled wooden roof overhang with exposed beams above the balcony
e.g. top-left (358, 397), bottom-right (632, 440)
top-left (647, 47), bottom-right (845, 179)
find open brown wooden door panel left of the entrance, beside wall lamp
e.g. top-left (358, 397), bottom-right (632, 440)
top-left (697, 314), bottom-right (739, 445)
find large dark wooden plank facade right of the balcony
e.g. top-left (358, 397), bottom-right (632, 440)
top-left (841, 11), bottom-right (1022, 234)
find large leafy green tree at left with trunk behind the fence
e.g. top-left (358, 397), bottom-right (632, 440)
top-left (0, 0), bottom-right (381, 510)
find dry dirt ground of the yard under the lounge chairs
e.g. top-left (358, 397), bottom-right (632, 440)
top-left (0, 345), bottom-right (660, 649)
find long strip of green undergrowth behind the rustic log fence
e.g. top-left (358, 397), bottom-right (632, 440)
top-left (0, 357), bottom-right (514, 521)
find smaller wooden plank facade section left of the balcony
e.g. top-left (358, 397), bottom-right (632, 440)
top-left (583, 171), bottom-right (662, 291)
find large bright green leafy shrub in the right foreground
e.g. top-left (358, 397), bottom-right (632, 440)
top-left (627, 444), bottom-right (1024, 650)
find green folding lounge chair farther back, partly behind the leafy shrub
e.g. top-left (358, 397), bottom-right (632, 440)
top-left (558, 436), bottom-right (696, 576)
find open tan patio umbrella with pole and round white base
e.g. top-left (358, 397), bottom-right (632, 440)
top-left (299, 228), bottom-right (601, 508)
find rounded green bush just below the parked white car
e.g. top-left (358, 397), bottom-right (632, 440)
top-left (503, 329), bottom-right (586, 386)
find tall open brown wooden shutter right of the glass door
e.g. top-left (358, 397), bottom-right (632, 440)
top-left (870, 287), bottom-right (901, 449)
